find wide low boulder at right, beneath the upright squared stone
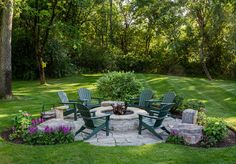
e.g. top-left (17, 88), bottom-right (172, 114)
top-left (171, 123), bottom-right (203, 144)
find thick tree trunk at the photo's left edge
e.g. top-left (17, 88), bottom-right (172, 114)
top-left (0, 0), bottom-right (13, 99)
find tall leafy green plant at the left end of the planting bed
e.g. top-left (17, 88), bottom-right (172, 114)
top-left (10, 110), bottom-right (32, 140)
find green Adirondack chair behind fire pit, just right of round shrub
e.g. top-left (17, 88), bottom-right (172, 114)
top-left (129, 89), bottom-right (154, 109)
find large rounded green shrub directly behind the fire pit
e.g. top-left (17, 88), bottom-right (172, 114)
top-left (97, 72), bottom-right (142, 101)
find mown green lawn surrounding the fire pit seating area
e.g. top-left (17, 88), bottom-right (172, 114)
top-left (0, 74), bottom-right (236, 163)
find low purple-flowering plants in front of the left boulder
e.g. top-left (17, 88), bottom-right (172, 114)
top-left (23, 126), bottom-right (74, 145)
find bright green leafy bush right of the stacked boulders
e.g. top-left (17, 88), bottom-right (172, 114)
top-left (201, 117), bottom-right (228, 147)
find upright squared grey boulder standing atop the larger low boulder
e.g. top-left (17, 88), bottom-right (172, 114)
top-left (182, 109), bottom-right (198, 124)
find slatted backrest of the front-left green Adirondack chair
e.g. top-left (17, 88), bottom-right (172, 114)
top-left (77, 104), bottom-right (95, 129)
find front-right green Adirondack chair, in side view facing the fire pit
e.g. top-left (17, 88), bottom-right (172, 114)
top-left (138, 103), bottom-right (174, 139)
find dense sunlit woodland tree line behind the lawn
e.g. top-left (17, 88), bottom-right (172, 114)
top-left (12, 0), bottom-right (236, 83)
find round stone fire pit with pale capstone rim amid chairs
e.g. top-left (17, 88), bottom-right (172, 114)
top-left (91, 106), bottom-right (147, 132)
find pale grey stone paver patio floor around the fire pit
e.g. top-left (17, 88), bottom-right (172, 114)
top-left (70, 118), bottom-right (181, 146)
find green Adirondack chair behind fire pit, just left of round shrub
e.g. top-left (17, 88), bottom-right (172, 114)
top-left (78, 88), bottom-right (102, 109)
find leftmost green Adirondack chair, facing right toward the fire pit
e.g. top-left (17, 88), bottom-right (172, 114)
top-left (57, 91), bottom-right (79, 120)
